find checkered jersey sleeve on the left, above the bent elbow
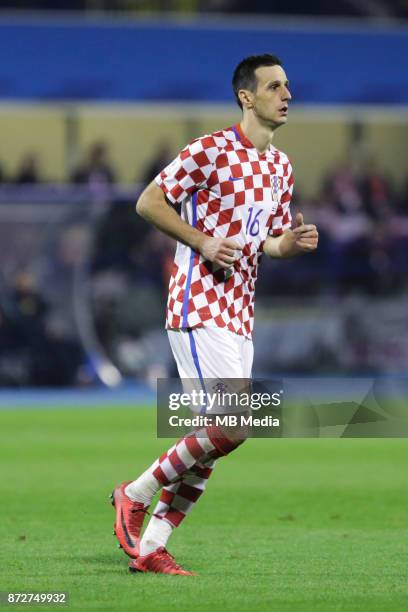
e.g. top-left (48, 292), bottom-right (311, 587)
top-left (154, 136), bottom-right (216, 205)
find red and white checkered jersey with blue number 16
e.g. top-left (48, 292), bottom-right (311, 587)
top-left (155, 125), bottom-right (293, 338)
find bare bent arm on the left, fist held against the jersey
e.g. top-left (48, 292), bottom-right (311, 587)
top-left (136, 181), bottom-right (240, 269)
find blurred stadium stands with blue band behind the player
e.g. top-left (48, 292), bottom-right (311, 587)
top-left (0, 0), bottom-right (408, 389)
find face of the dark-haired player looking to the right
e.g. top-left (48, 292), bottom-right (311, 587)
top-left (252, 66), bottom-right (292, 128)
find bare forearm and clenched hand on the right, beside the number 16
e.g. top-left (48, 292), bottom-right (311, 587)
top-left (263, 213), bottom-right (319, 257)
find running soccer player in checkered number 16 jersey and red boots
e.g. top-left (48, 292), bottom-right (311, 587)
top-left (112, 54), bottom-right (318, 575)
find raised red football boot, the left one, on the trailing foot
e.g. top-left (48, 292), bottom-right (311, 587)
top-left (111, 481), bottom-right (149, 559)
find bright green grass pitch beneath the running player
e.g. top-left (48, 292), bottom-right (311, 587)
top-left (0, 408), bottom-right (408, 612)
